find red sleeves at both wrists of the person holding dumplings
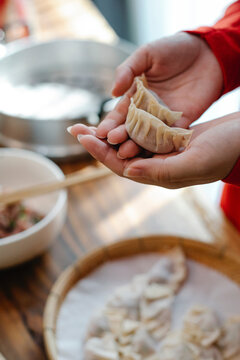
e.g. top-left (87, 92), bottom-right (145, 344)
top-left (187, 0), bottom-right (240, 190)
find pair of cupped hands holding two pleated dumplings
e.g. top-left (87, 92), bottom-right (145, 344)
top-left (67, 33), bottom-right (240, 188)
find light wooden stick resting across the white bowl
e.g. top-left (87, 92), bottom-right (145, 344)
top-left (0, 167), bottom-right (112, 205)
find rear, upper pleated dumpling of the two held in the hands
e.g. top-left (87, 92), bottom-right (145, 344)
top-left (133, 76), bottom-right (182, 126)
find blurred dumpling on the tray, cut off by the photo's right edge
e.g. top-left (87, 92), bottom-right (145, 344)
top-left (218, 317), bottom-right (240, 360)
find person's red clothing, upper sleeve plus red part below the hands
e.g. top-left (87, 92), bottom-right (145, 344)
top-left (188, 0), bottom-right (240, 231)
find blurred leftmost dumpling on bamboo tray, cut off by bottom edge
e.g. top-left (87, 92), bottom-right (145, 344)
top-left (84, 334), bottom-right (119, 360)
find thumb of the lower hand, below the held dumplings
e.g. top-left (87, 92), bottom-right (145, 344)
top-left (123, 149), bottom-right (203, 189)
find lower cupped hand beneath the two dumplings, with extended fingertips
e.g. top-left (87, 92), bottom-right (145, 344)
top-left (68, 113), bottom-right (240, 189)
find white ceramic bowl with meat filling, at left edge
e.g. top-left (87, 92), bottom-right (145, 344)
top-left (0, 149), bottom-right (67, 269)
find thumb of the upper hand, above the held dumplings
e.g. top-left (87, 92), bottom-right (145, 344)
top-left (112, 45), bottom-right (151, 96)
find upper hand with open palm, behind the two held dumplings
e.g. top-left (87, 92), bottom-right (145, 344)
top-left (78, 33), bottom-right (223, 158)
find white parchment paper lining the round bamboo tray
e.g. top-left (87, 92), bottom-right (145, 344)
top-left (56, 254), bottom-right (240, 360)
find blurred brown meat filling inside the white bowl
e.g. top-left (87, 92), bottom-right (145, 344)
top-left (0, 203), bottom-right (43, 239)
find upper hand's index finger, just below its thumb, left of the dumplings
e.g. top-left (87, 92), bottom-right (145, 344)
top-left (96, 96), bottom-right (130, 139)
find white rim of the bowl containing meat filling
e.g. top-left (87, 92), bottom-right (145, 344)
top-left (0, 148), bottom-right (67, 247)
